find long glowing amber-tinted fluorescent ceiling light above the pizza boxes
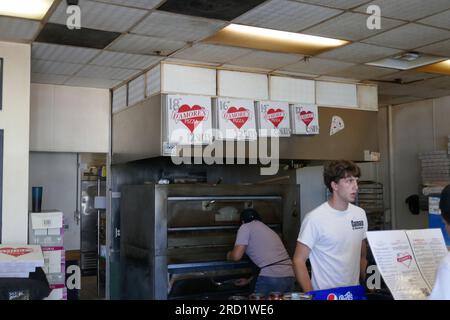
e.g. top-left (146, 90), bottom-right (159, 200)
top-left (203, 24), bottom-right (349, 55)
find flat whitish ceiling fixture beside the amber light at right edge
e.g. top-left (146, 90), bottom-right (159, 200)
top-left (366, 52), bottom-right (446, 70)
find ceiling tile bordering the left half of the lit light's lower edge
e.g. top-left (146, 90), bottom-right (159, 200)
top-left (173, 44), bottom-right (251, 64)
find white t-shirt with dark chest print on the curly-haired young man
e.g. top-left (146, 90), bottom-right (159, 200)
top-left (297, 202), bottom-right (367, 290)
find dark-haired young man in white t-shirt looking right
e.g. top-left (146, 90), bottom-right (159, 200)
top-left (293, 160), bottom-right (367, 292)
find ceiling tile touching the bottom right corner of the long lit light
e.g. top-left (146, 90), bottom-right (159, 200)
top-left (280, 58), bottom-right (353, 75)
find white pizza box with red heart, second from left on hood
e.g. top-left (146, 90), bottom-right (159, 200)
top-left (216, 98), bottom-right (257, 140)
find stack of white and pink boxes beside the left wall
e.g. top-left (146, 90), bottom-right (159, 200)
top-left (29, 211), bottom-right (67, 300)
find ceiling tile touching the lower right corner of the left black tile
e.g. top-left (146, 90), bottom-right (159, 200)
top-left (90, 51), bottom-right (162, 70)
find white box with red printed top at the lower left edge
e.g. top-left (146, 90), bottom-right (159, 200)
top-left (0, 244), bottom-right (44, 278)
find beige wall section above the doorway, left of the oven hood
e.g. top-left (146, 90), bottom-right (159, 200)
top-left (30, 83), bottom-right (110, 153)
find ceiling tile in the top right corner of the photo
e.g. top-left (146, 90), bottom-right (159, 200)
top-left (355, 0), bottom-right (450, 21)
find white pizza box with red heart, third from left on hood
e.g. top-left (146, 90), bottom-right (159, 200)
top-left (256, 101), bottom-right (291, 137)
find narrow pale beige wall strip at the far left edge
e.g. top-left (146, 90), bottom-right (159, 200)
top-left (0, 42), bottom-right (31, 243)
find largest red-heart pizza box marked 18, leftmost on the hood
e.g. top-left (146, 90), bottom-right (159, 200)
top-left (164, 94), bottom-right (213, 145)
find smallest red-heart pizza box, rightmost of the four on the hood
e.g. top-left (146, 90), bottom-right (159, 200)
top-left (292, 103), bottom-right (319, 135)
